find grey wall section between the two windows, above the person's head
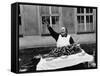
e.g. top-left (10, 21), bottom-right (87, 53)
top-left (62, 7), bottom-right (75, 33)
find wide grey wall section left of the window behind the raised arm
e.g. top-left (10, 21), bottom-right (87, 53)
top-left (21, 5), bottom-right (39, 36)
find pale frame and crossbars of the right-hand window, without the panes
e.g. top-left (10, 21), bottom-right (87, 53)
top-left (74, 7), bottom-right (95, 34)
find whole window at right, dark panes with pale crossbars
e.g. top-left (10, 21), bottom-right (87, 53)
top-left (76, 7), bottom-right (94, 33)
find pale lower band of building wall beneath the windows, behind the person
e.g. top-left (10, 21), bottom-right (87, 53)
top-left (19, 34), bottom-right (96, 49)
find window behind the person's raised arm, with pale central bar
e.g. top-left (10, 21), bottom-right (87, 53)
top-left (40, 6), bottom-right (60, 34)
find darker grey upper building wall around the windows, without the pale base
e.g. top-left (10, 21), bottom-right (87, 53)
top-left (19, 5), bottom-right (96, 36)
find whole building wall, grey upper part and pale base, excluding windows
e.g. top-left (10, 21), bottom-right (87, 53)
top-left (19, 5), bottom-right (96, 48)
